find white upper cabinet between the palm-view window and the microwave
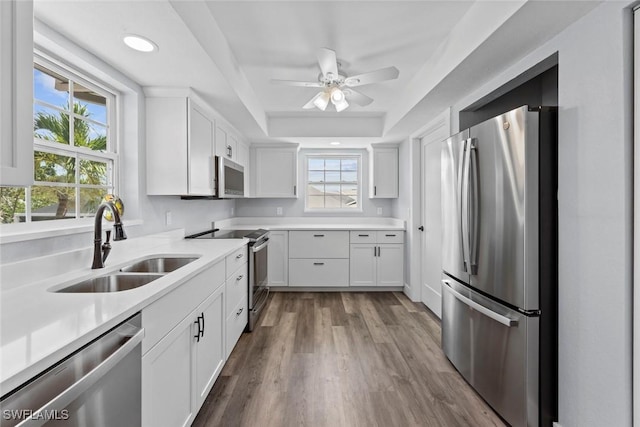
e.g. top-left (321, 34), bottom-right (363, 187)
top-left (146, 94), bottom-right (215, 196)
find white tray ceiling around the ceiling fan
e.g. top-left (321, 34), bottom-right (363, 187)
top-left (35, 0), bottom-right (599, 146)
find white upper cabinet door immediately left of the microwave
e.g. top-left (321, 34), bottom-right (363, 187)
top-left (188, 100), bottom-right (215, 196)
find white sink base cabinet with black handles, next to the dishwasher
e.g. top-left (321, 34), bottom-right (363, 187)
top-left (142, 261), bottom-right (226, 427)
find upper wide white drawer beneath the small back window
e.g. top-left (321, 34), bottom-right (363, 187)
top-left (289, 230), bottom-right (349, 258)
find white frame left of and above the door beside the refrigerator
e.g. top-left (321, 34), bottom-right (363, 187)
top-left (405, 107), bottom-right (451, 302)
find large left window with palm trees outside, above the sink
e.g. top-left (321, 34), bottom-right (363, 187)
top-left (0, 59), bottom-right (117, 223)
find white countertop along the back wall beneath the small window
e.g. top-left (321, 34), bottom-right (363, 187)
top-left (215, 217), bottom-right (406, 230)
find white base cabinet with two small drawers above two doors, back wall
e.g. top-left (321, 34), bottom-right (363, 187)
top-left (349, 230), bottom-right (404, 286)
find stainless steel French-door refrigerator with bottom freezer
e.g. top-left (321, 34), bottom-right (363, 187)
top-left (441, 106), bottom-right (557, 426)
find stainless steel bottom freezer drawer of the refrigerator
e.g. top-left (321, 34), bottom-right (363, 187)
top-left (442, 278), bottom-right (539, 427)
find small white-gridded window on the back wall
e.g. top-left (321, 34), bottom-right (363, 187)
top-left (305, 155), bottom-right (361, 211)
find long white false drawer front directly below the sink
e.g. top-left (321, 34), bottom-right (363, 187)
top-left (142, 261), bottom-right (224, 354)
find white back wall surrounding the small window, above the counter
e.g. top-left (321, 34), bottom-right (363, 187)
top-left (236, 149), bottom-right (392, 217)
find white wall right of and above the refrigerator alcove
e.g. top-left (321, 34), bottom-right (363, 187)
top-left (452, 1), bottom-right (633, 427)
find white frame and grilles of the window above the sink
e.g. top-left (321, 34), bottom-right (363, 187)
top-left (11, 53), bottom-right (120, 227)
